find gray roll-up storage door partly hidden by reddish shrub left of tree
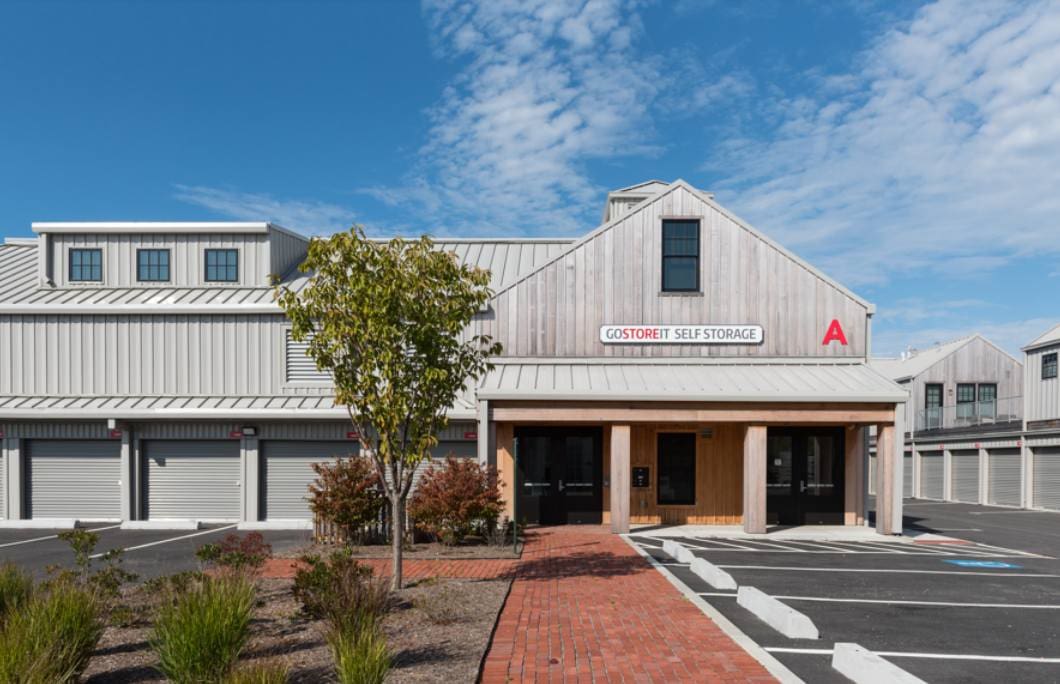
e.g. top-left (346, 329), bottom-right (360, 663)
top-left (260, 439), bottom-right (358, 521)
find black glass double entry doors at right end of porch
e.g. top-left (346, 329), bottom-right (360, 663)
top-left (765, 427), bottom-right (846, 525)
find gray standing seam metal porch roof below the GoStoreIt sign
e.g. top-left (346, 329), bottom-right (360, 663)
top-left (478, 358), bottom-right (907, 403)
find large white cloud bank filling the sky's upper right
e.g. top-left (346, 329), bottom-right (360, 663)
top-left (708, 0), bottom-right (1060, 285)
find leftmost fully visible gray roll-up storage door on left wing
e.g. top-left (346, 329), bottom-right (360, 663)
top-left (23, 439), bottom-right (122, 520)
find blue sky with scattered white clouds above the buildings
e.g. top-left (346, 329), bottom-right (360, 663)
top-left (0, 0), bottom-right (1060, 353)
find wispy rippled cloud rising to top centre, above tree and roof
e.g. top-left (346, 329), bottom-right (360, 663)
top-left (363, 0), bottom-right (661, 233)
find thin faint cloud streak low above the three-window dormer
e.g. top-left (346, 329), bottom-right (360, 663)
top-left (174, 185), bottom-right (354, 235)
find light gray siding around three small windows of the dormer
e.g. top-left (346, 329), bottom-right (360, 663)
top-left (50, 233), bottom-right (271, 287)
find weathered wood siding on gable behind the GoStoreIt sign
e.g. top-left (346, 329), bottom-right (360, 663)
top-left (476, 187), bottom-right (867, 357)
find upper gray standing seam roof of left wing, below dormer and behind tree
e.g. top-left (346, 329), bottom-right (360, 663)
top-left (0, 238), bottom-right (573, 313)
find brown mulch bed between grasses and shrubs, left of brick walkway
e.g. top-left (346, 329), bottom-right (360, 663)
top-left (83, 579), bottom-right (511, 683)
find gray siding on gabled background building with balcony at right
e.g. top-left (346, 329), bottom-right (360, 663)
top-left (903, 337), bottom-right (1023, 429)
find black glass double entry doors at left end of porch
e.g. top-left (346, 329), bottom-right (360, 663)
top-left (515, 427), bottom-right (603, 525)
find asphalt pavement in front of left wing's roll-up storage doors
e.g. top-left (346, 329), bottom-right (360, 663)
top-left (0, 524), bottom-right (311, 579)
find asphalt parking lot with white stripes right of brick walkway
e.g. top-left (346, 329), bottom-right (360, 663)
top-left (631, 501), bottom-right (1060, 682)
